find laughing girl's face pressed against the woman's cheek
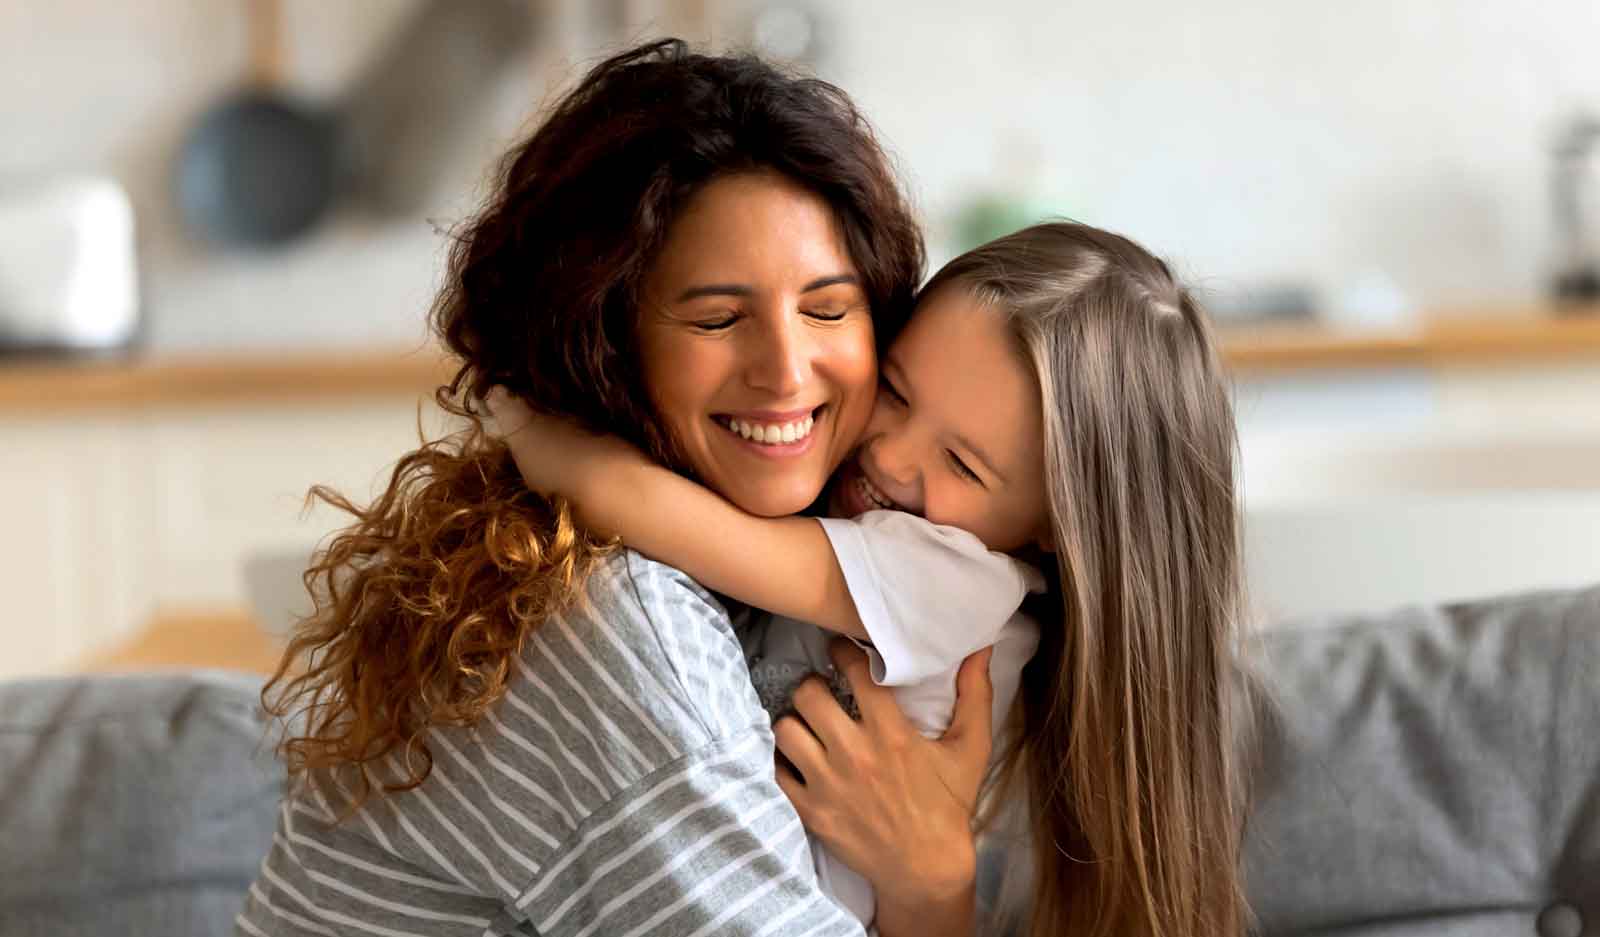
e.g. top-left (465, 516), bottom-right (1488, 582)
top-left (830, 283), bottom-right (1050, 552)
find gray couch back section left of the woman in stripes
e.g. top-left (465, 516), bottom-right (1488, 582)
top-left (0, 673), bottom-right (283, 937)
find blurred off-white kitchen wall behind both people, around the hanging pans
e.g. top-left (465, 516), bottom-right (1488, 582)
top-left (0, 0), bottom-right (1600, 347)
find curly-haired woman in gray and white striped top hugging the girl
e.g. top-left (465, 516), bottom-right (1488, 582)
top-left (238, 42), bottom-right (987, 935)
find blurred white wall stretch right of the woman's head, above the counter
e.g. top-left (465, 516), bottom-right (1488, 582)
top-left (824, 0), bottom-right (1600, 313)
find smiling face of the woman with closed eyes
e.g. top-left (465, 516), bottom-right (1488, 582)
top-left (638, 173), bottom-right (877, 516)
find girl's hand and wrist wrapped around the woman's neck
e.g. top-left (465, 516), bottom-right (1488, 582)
top-left (483, 387), bottom-right (650, 502)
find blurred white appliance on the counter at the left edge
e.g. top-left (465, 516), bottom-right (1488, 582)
top-left (0, 177), bottom-right (139, 352)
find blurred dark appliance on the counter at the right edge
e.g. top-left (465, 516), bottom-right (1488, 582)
top-left (1550, 114), bottom-right (1600, 302)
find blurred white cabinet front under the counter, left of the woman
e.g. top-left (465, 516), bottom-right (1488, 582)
top-left (0, 395), bottom-right (464, 678)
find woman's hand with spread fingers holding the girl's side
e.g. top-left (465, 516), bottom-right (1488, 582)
top-left (774, 640), bottom-right (994, 934)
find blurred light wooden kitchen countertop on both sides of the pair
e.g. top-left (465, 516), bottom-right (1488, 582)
top-left (0, 307), bottom-right (1600, 414)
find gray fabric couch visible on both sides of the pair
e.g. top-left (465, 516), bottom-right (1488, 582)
top-left (0, 588), bottom-right (1600, 937)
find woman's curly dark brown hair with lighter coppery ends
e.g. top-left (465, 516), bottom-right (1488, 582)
top-left (262, 40), bottom-right (923, 807)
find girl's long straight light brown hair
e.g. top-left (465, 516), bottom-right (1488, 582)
top-left (925, 222), bottom-right (1246, 937)
